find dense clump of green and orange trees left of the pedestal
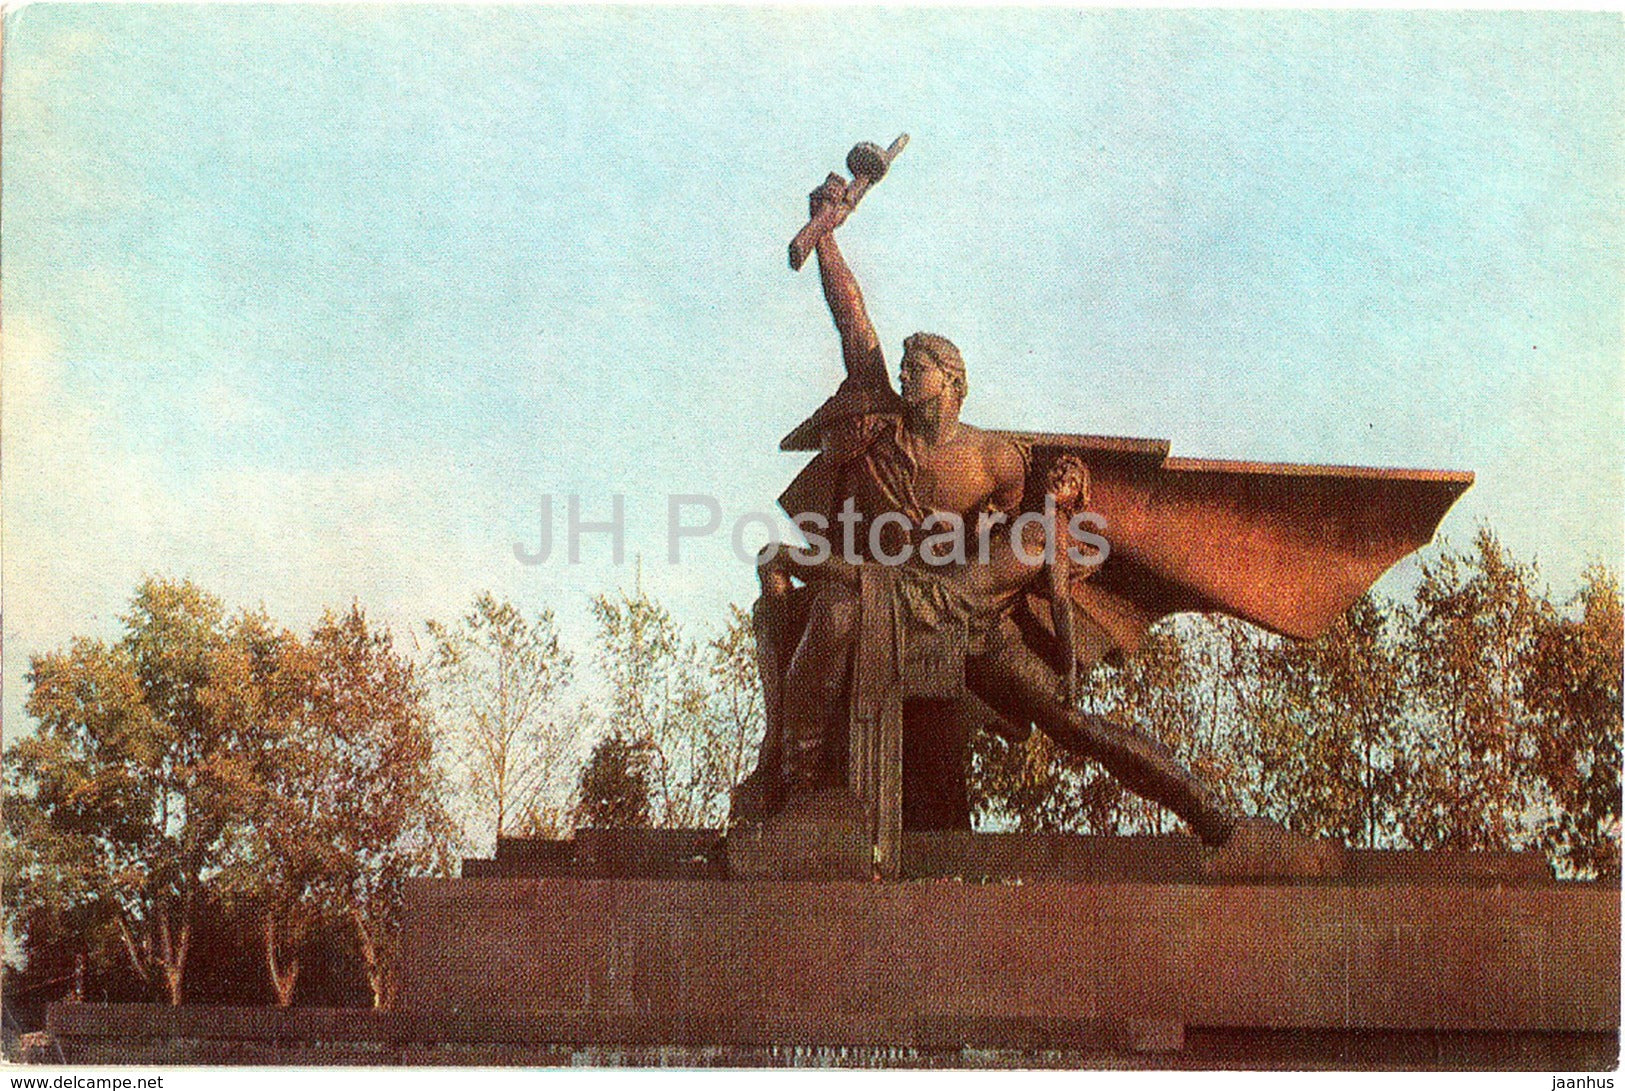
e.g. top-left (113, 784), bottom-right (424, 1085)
top-left (5, 579), bottom-right (450, 1003)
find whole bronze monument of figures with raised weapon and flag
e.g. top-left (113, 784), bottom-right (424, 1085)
top-left (731, 137), bottom-right (1472, 876)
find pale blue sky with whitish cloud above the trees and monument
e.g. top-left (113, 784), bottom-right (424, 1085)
top-left (0, 5), bottom-right (1625, 732)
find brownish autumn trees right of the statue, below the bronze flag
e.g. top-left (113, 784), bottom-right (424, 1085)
top-left (970, 530), bottom-right (1622, 876)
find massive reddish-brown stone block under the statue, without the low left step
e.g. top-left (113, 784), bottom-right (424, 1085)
top-left (386, 834), bottom-right (1620, 1063)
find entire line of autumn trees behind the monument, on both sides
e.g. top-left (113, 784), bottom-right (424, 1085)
top-left (0, 530), bottom-right (1622, 1006)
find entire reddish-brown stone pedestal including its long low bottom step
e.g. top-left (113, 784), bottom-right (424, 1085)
top-left (31, 838), bottom-right (1620, 1070)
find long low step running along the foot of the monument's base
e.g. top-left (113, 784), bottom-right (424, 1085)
top-left (31, 1003), bottom-right (1619, 1071)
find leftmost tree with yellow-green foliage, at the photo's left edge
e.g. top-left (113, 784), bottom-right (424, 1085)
top-left (5, 579), bottom-right (242, 1005)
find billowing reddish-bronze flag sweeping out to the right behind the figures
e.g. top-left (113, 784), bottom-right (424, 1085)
top-left (778, 426), bottom-right (1472, 662)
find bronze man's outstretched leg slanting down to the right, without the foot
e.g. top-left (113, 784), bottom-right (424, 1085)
top-left (965, 619), bottom-right (1235, 845)
